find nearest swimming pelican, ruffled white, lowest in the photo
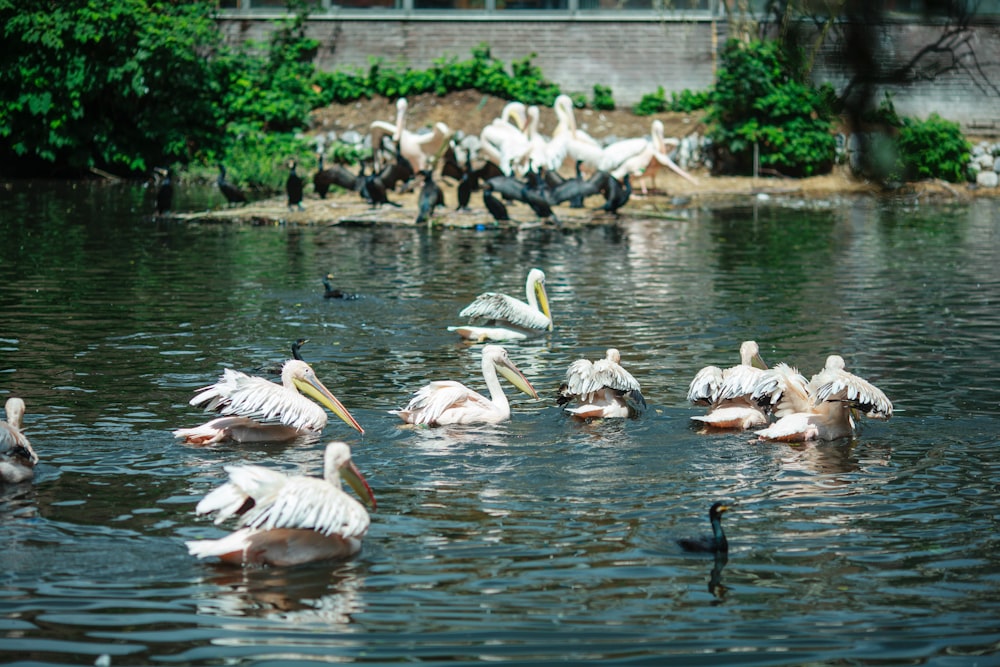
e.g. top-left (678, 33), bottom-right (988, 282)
top-left (187, 442), bottom-right (376, 566)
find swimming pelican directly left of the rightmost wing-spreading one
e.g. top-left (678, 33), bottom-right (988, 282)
top-left (688, 340), bottom-right (768, 429)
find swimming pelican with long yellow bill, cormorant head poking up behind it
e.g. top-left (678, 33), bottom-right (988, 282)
top-left (174, 359), bottom-right (365, 445)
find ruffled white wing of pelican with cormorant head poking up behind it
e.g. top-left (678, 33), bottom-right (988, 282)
top-left (191, 368), bottom-right (326, 430)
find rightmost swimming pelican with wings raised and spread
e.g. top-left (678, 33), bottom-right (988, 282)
top-left (754, 354), bottom-right (892, 442)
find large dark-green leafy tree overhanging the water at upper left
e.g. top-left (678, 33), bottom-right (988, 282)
top-left (0, 0), bottom-right (224, 174)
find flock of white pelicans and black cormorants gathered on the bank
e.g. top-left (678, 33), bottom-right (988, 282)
top-left (156, 95), bottom-right (697, 224)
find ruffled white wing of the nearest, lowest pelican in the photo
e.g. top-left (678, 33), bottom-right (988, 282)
top-left (243, 477), bottom-right (370, 537)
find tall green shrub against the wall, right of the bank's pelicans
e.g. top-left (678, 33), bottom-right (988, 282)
top-left (708, 40), bottom-right (836, 176)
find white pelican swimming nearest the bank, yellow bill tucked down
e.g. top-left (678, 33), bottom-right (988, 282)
top-left (448, 269), bottom-right (552, 341)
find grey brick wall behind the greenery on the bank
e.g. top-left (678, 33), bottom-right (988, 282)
top-left (221, 15), bottom-right (1000, 133)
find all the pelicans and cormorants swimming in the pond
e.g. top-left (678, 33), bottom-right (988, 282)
top-left (0, 269), bottom-right (892, 565)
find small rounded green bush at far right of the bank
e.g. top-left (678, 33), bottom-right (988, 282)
top-left (896, 114), bottom-right (971, 183)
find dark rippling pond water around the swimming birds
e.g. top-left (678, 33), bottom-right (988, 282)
top-left (0, 183), bottom-right (1000, 665)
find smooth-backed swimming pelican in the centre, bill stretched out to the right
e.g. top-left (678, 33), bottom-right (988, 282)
top-left (390, 345), bottom-right (538, 426)
